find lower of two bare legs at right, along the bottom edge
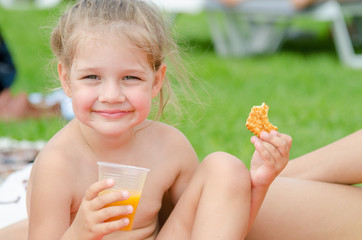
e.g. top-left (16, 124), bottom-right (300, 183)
top-left (246, 177), bottom-right (362, 240)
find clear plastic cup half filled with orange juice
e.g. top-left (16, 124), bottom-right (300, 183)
top-left (97, 162), bottom-right (150, 231)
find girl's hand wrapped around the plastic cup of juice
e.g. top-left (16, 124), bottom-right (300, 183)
top-left (70, 179), bottom-right (133, 240)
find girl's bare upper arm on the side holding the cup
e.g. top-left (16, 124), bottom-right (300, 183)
top-left (27, 154), bottom-right (72, 240)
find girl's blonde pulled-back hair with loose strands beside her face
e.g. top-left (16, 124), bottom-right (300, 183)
top-left (51, 0), bottom-right (192, 118)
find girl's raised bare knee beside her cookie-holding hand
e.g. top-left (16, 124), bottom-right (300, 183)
top-left (200, 152), bottom-right (251, 193)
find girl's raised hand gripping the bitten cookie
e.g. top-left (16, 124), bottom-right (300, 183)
top-left (250, 131), bottom-right (292, 187)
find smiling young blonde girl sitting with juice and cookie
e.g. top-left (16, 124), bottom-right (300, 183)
top-left (27, 0), bottom-right (291, 240)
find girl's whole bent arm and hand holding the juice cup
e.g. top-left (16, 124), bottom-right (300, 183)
top-left (28, 154), bottom-right (133, 240)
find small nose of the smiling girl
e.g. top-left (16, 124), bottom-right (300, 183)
top-left (99, 82), bottom-right (126, 103)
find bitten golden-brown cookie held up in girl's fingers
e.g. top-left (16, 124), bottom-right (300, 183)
top-left (245, 103), bottom-right (278, 137)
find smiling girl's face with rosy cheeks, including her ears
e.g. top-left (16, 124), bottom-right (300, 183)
top-left (58, 34), bottom-right (166, 135)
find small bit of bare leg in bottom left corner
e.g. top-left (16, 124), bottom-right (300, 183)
top-left (0, 219), bottom-right (28, 240)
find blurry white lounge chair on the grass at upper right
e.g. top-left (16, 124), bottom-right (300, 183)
top-left (205, 0), bottom-right (362, 68)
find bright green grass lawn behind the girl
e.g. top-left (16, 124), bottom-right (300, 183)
top-left (0, 5), bottom-right (362, 165)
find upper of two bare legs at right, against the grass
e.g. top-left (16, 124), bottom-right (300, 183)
top-left (281, 130), bottom-right (362, 184)
